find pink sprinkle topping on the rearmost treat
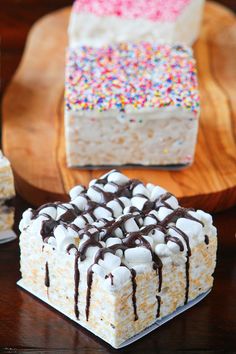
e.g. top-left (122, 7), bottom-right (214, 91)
top-left (73, 0), bottom-right (192, 21)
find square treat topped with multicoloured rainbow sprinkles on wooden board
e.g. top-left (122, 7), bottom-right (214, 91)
top-left (65, 42), bottom-right (199, 167)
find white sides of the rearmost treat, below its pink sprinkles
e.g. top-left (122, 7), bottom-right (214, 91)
top-left (69, 0), bottom-right (204, 47)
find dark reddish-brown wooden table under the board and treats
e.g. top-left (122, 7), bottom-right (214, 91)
top-left (0, 0), bottom-right (236, 354)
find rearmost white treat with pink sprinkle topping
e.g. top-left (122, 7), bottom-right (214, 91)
top-left (69, 0), bottom-right (204, 47)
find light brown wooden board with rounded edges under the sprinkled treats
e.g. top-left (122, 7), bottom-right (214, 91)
top-left (3, 2), bottom-right (236, 211)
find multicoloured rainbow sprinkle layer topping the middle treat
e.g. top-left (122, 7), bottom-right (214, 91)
top-left (65, 42), bottom-right (199, 115)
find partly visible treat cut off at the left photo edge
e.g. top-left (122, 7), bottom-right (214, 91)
top-left (0, 151), bottom-right (15, 232)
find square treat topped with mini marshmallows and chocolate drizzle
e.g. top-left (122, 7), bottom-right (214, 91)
top-left (20, 170), bottom-right (217, 347)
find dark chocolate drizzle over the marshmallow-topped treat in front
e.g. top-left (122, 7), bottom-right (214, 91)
top-left (27, 171), bottom-right (206, 321)
